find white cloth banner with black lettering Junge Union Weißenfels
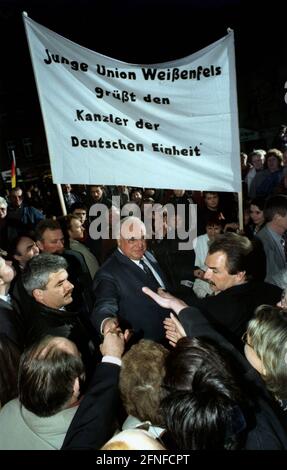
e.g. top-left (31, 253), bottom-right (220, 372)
top-left (23, 15), bottom-right (241, 191)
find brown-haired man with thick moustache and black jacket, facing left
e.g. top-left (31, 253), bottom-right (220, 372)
top-left (146, 232), bottom-right (282, 349)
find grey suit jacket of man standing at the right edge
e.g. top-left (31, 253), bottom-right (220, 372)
top-left (257, 225), bottom-right (286, 284)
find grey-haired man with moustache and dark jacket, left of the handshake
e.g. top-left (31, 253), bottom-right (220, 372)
top-left (22, 253), bottom-right (97, 372)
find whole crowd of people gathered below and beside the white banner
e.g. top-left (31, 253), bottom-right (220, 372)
top-left (0, 141), bottom-right (287, 452)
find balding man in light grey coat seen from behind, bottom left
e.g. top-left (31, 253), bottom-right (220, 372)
top-left (0, 336), bottom-right (84, 450)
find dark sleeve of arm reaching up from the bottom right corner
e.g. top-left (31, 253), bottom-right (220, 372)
top-left (179, 307), bottom-right (287, 450)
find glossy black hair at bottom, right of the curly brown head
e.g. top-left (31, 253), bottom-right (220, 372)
top-left (161, 338), bottom-right (246, 450)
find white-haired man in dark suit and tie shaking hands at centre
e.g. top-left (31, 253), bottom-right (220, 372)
top-left (91, 217), bottom-right (170, 342)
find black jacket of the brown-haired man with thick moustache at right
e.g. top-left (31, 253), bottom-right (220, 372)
top-left (187, 281), bottom-right (282, 348)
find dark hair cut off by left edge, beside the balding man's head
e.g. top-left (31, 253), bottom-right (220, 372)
top-left (0, 333), bottom-right (20, 408)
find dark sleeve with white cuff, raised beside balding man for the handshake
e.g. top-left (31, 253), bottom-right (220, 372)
top-left (62, 362), bottom-right (120, 450)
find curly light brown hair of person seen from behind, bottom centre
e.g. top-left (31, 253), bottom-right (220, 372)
top-left (119, 339), bottom-right (168, 425)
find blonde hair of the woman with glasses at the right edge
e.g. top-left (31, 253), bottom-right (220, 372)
top-left (247, 305), bottom-right (287, 399)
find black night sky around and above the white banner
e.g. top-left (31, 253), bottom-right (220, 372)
top-left (0, 0), bottom-right (287, 183)
